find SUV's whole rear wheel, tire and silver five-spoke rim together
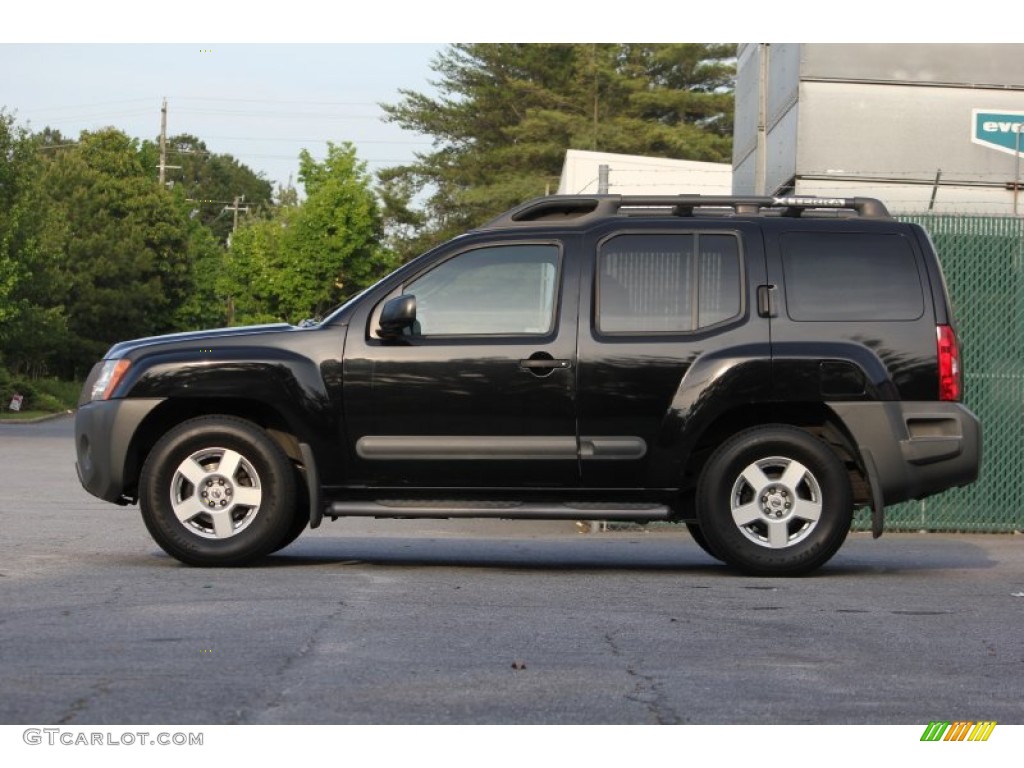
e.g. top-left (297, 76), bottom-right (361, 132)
top-left (697, 424), bottom-right (853, 577)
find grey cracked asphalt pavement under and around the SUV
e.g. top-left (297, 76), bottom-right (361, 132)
top-left (0, 417), bottom-right (1024, 728)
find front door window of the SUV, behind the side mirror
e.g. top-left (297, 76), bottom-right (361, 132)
top-left (404, 244), bottom-right (559, 336)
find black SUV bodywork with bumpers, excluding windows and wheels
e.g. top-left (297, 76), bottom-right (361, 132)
top-left (77, 196), bottom-right (980, 522)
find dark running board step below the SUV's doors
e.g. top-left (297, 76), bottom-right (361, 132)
top-left (326, 500), bottom-right (672, 522)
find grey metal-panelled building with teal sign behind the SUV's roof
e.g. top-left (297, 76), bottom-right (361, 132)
top-left (733, 44), bottom-right (1024, 215)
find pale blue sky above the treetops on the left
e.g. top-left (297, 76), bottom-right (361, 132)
top-left (0, 43), bottom-right (445, 192)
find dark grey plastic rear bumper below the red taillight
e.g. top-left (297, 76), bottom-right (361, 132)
top-left (828, 401), bottom-right (981, 510)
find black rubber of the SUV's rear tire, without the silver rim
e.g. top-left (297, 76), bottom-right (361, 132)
top-left (697, 425), bottom-right (853, 575)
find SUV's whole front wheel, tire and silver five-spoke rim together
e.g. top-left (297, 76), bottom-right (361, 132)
top-left (139, 416), bottom-right (298, 566)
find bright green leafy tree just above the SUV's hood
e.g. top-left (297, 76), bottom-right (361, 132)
top-left (219, 142), bottom-right (395, 323)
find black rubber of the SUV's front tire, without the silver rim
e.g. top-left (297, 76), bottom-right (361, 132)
top-left (139, 417), bottom-right (296, 565)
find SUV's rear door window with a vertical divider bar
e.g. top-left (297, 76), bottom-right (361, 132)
top-left (597, 233), bottom-right (740, 334)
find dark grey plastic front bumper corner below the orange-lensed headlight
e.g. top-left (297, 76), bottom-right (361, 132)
top-left (75, 398), bottom-right (163, 504)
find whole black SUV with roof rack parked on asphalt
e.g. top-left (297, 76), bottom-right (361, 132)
top-left (76, 196), bottom-right (981, 575)
